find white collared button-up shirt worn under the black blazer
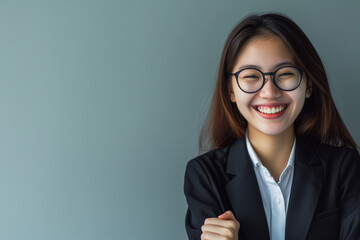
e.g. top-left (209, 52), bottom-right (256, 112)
top-left (246, 134), bottom-right (296, 240)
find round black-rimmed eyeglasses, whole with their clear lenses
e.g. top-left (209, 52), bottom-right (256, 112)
top-left (231, 66), bottom-right (303, 93)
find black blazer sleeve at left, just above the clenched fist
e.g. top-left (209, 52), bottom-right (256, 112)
top-left (184, 158), bottom-right (222, 240)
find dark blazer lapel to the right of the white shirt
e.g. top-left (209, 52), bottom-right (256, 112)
top-left (285, 136), bottom-right (323, 240)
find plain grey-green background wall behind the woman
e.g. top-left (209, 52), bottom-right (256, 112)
top-left (0, 0), bottom-right (360, 240)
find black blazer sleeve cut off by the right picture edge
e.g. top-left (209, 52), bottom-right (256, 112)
top-left (339, 150), bottom-right (360, 240)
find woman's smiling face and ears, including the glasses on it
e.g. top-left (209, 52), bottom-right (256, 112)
top-left (230, 34), bottom-right (309, 143)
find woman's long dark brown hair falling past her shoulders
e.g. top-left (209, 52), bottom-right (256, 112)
top-left (199, 14), bottom-right (357, 151)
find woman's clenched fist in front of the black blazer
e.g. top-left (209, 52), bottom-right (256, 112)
top-left (201, 211), bottom-right (240, 240)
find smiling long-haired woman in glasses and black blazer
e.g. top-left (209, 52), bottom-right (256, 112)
top-left (184, 14), bottom-right (360, 240)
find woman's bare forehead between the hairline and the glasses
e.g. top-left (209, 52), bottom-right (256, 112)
top-left (234, 34), bottom-right (294, 71)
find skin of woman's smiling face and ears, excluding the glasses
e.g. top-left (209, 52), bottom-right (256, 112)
top-left (229, 34), bottom-right (307, 139)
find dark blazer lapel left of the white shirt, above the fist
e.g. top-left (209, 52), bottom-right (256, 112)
top-left (226, 139), bottom-right (270, 240)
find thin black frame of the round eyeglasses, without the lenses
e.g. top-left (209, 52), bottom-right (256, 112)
top-left (231, 66), bottom-right (304, 93)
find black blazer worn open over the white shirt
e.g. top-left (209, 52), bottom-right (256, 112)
top-left (184, 136), bottom-right (360, 240)
